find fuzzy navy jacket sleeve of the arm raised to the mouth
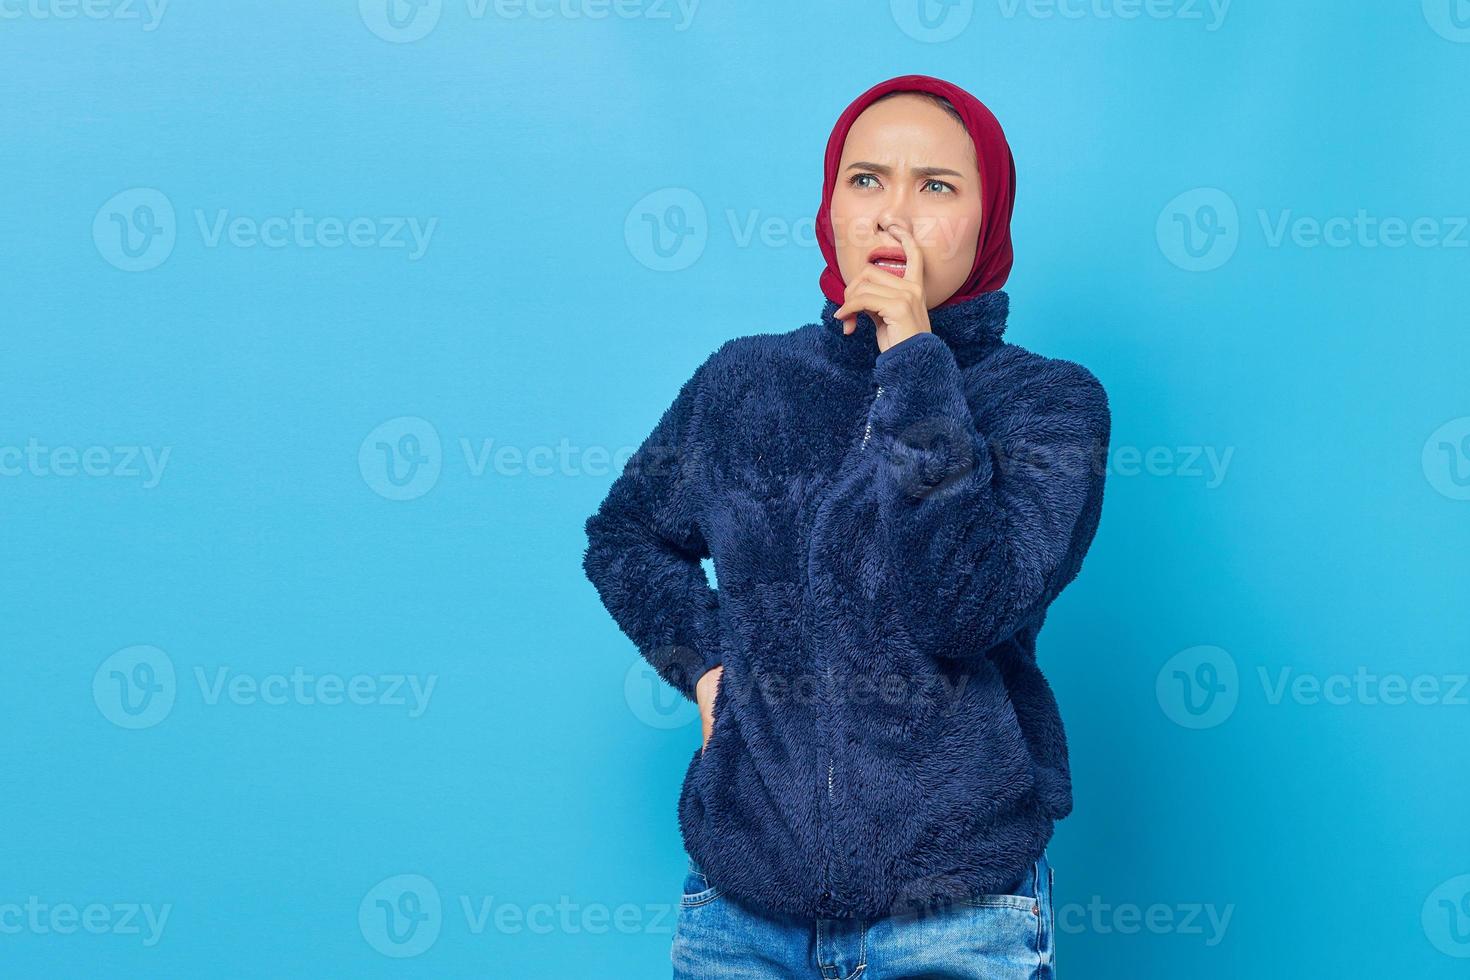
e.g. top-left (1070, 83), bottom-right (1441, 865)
top-left (864, 332), bottom-right (1111, 657)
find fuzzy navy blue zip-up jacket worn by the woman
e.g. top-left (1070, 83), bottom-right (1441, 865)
top-left (582, 289), bottom-right (1110, 918)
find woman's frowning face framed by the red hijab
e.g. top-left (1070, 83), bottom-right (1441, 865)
top-left (831, 94), bottom-right (982, 310)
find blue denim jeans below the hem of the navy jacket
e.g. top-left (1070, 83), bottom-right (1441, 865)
top-left (672, 852), bottom-right (1055, 980)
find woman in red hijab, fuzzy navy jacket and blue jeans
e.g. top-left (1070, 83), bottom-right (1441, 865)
top-left (584, 75), bottom-right (1110, 980)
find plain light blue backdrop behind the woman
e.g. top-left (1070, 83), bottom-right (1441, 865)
top-left (0, 0), bottom-right (1470, 980)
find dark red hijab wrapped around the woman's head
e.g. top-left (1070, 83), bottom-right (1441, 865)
top-left (817, 75), bottom-right (1016, 309)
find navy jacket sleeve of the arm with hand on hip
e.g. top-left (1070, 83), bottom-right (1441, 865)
top-left (582, 361), bottom-right (722, 701)
